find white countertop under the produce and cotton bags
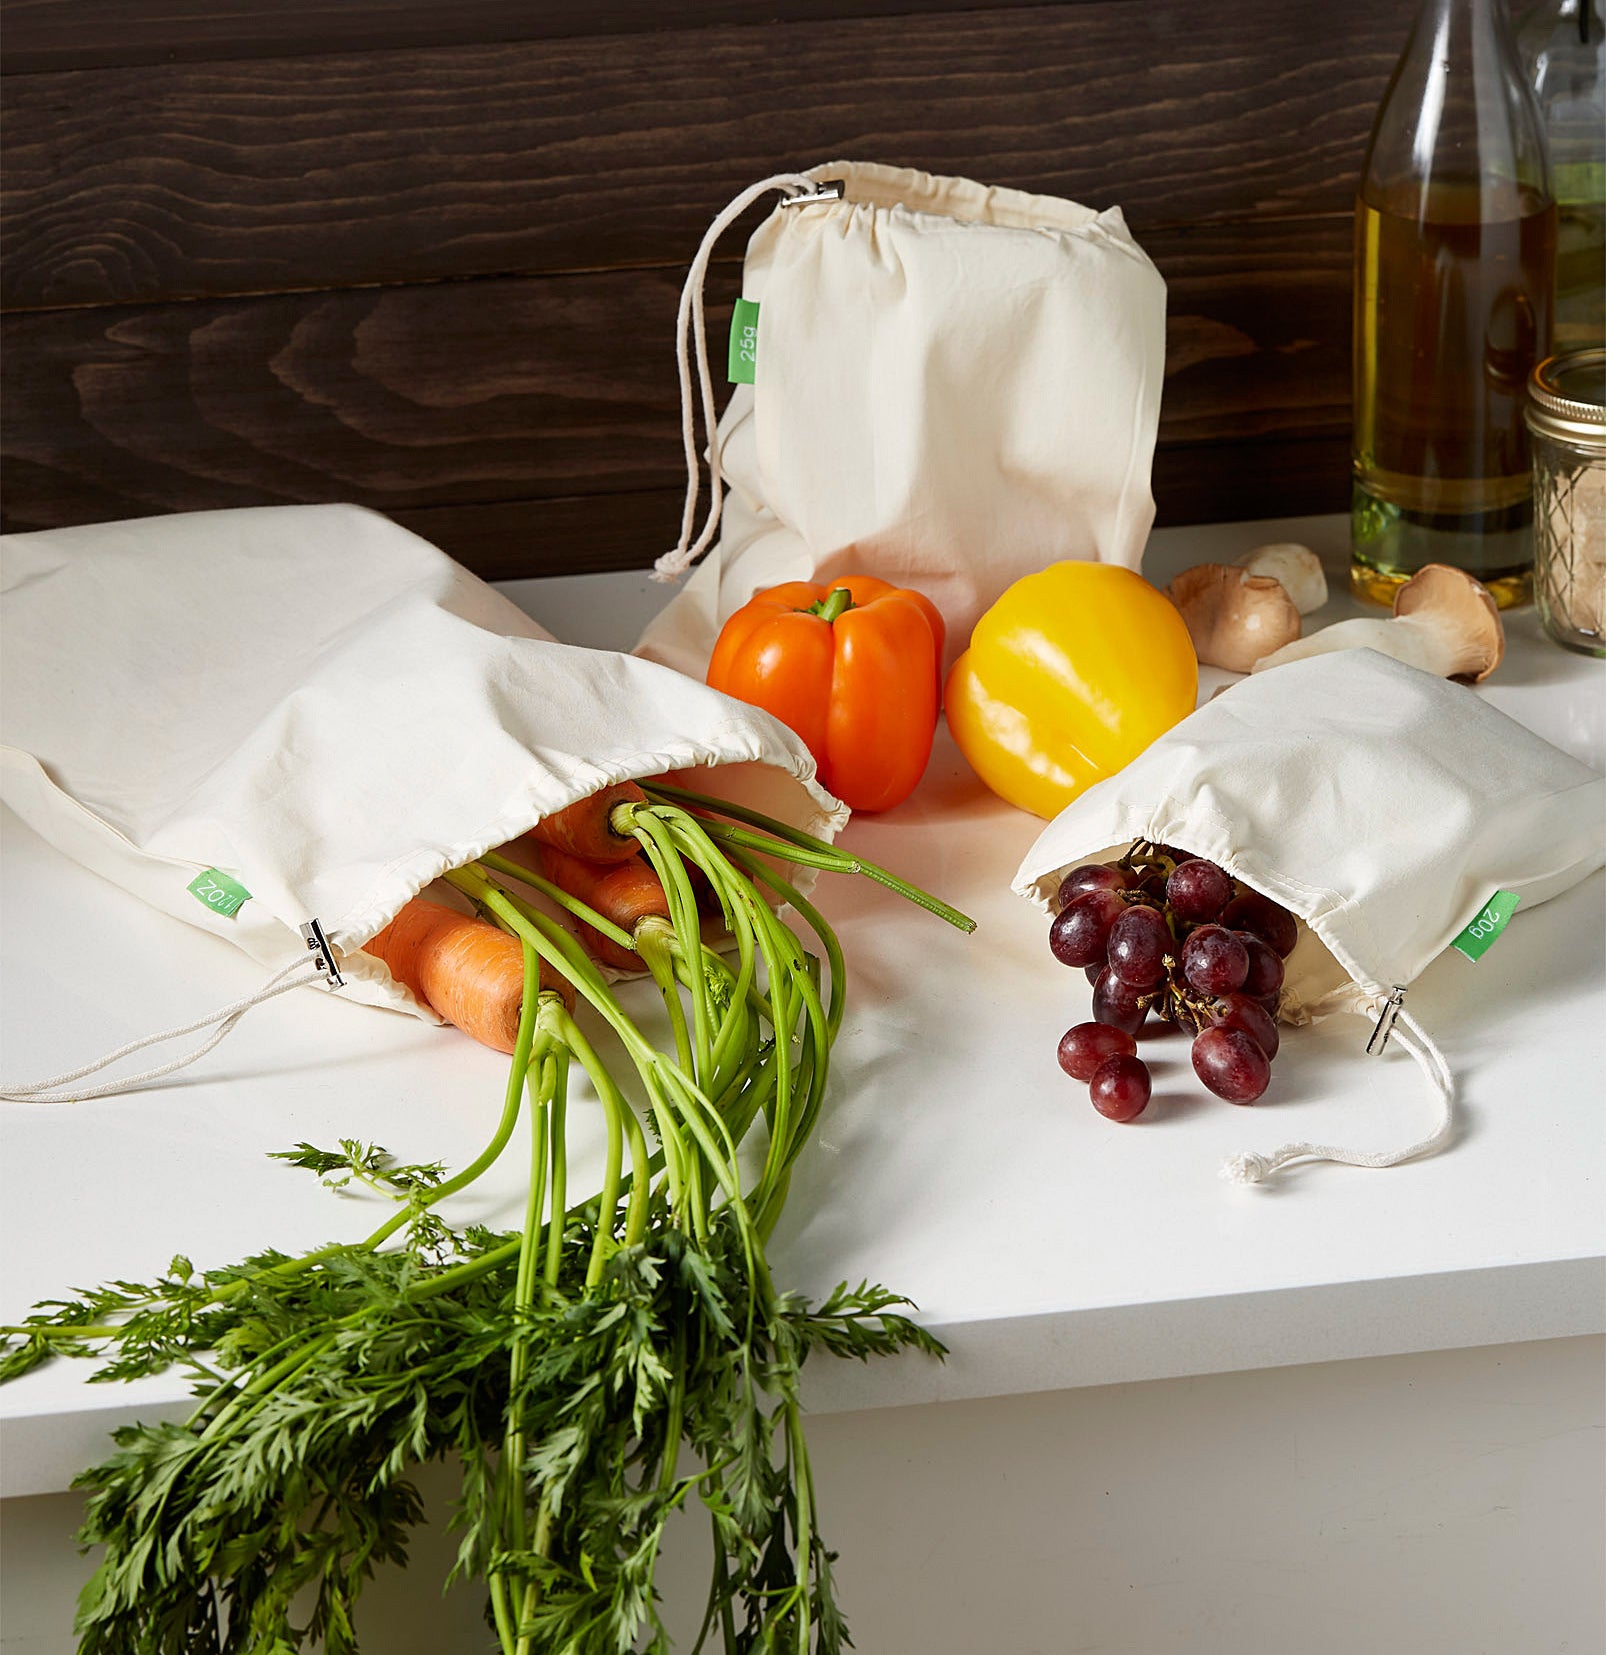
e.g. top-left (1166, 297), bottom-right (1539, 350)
top-left (0, 518), bottom-right (1606, 1496)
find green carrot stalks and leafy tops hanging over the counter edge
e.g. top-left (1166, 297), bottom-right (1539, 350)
top-left (6, 789), bottom-right (969, 1655)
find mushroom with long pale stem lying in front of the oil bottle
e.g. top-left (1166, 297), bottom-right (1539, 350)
top-left (1253, 563), bottom-right (1505, 684)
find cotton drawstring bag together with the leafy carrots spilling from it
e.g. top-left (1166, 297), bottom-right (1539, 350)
top-left (0, 506), bottom-right (969, 1655)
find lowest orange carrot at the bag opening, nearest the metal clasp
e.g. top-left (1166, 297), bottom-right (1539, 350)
top-left (363, 897), bottom-right (575, 1053)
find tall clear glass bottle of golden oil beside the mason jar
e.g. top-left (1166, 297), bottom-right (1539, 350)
top-left (1349, 0), bottom-right (1556, 606)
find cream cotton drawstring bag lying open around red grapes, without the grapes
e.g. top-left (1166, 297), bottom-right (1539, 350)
top-left (1015, 649), bottom-right (1606, 1183)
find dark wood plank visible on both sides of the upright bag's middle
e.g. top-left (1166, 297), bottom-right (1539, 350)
top-left (0, 218), bottom-right (1349, 526)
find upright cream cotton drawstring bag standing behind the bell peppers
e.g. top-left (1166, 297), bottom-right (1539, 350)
top-left (639, 161), bottom-right (1166, 677)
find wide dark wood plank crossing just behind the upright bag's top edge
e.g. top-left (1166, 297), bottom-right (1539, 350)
top-left (0, 0), bottom-right (1402, 308)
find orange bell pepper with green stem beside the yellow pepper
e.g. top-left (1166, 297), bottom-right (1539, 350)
top-left (707, 574), bottom-right (944, 811)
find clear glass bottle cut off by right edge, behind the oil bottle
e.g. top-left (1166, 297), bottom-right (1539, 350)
top-left (1513, 0), bottom-right (1606, 351)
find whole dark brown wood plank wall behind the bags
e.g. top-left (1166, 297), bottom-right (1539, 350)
top-left (0, 0), bottom-right (1390, 574)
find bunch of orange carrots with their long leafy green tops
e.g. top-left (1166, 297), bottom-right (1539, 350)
top-left (0, 784), bottom-right (972, 1655)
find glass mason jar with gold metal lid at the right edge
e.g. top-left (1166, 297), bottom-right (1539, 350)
top-left (1527, 346), bottom-right (1606, 655)
